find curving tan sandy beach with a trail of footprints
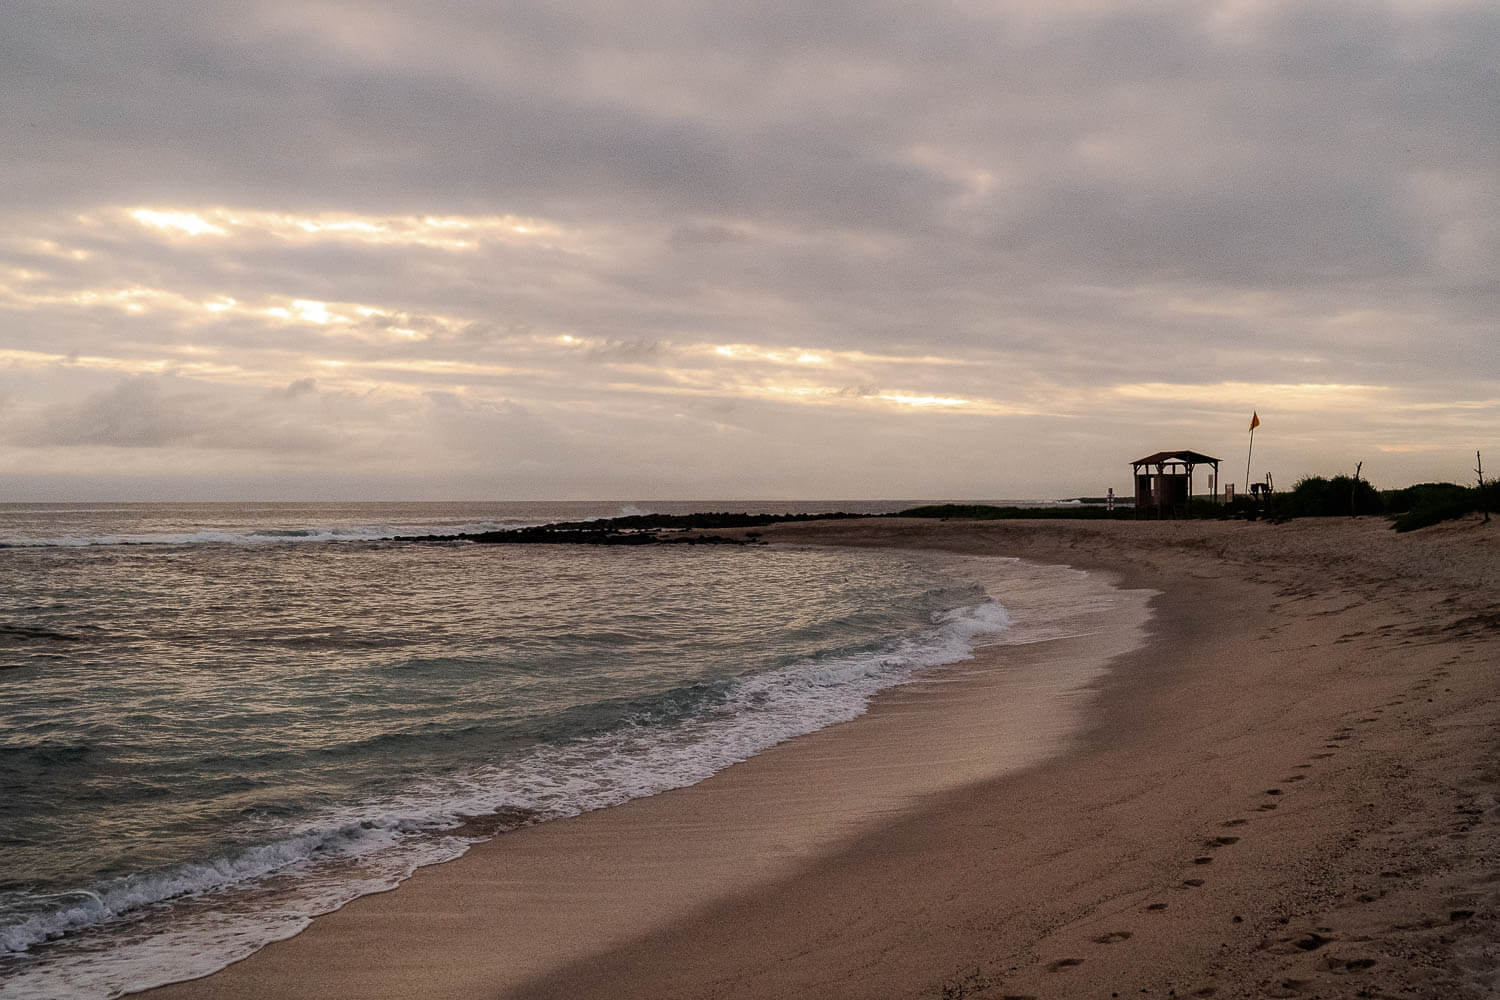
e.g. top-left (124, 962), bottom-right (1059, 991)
top-left (144, 519), bottom-right (1500, 1000)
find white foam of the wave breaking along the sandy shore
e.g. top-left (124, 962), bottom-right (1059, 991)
top-left (0, 603), bottom-right (1010, 1000)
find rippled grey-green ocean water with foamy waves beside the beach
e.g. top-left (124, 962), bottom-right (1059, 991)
top-left (0, 501), bottom-right (1116, 1000)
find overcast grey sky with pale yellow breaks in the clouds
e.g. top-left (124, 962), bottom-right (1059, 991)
top-left (0, 0), bottom-right (1500, 499)
